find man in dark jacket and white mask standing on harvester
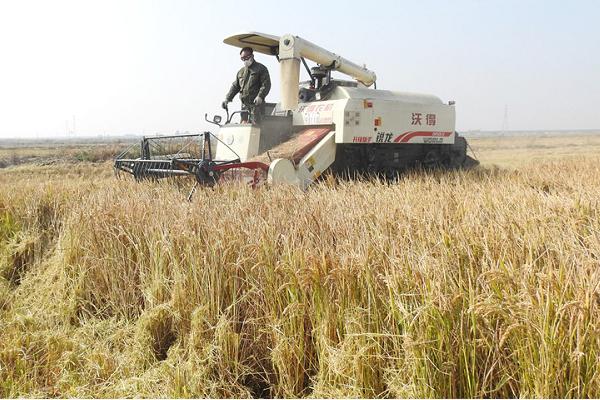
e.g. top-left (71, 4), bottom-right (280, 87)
top-left (222, 47), bottom-right (271, 122)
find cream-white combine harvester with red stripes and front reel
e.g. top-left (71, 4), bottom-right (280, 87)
top-left (114, 32), bottom-right (479, 192)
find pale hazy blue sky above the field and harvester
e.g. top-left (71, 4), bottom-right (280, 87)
top-left (0, 0), bottom-right (600, 137)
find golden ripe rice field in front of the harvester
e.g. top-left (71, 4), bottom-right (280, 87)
top-left (0, 136), bottom-right (600, 398)
